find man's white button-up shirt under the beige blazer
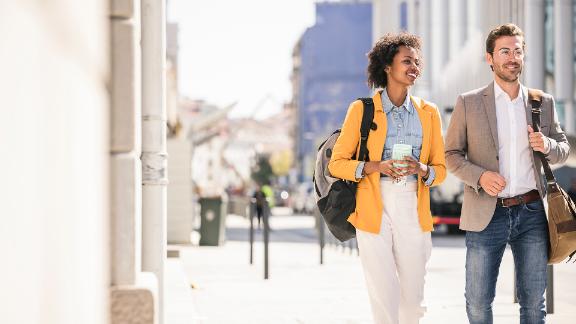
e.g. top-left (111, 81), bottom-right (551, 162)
top-left (494, 82), bottom-right (536, 198)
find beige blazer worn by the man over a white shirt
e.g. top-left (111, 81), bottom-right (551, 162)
top-left (445, 82), bottom-right (570, 232)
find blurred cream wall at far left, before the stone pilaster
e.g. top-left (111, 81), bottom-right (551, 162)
top-left (0, 0), bottom-right (110, 324)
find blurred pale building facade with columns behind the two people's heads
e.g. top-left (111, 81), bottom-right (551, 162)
top-left (373, 0), bottom-right (576, 135)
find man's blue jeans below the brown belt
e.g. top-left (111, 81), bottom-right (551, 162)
top-left (465, 200), bottom-right (548, 324)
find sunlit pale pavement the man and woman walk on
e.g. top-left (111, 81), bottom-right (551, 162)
top-left (166, 210), bottom-right (576, 324)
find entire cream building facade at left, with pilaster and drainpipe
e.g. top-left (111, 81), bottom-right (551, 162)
top-left (0, 0), bottom-right (167, 324)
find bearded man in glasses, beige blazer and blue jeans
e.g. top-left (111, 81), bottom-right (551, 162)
top-left (446, 24), bottom-right (570, 324)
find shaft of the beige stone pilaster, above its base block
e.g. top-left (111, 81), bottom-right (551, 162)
top-left (110, 0), bottom-right (142, 285)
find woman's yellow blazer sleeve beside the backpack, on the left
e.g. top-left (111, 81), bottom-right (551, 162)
top-left (328, 100), bottom-right (364, 182)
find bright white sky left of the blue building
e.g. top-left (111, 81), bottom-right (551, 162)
top-left (167, 0), bottom-right (315, 119)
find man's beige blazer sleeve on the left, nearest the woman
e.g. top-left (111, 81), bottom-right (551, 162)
top-left (445, 95), bottom-right (486, 193)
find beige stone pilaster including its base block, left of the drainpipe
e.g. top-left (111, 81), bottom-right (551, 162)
top-left (110, 0), bottom-right (158, 324)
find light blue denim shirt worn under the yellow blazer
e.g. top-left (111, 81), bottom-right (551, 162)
top-left (356, 89), bottom-right (436, 186)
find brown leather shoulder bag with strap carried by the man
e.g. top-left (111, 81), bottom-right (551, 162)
top-left (528, 89), bottom-right (576, 264)
